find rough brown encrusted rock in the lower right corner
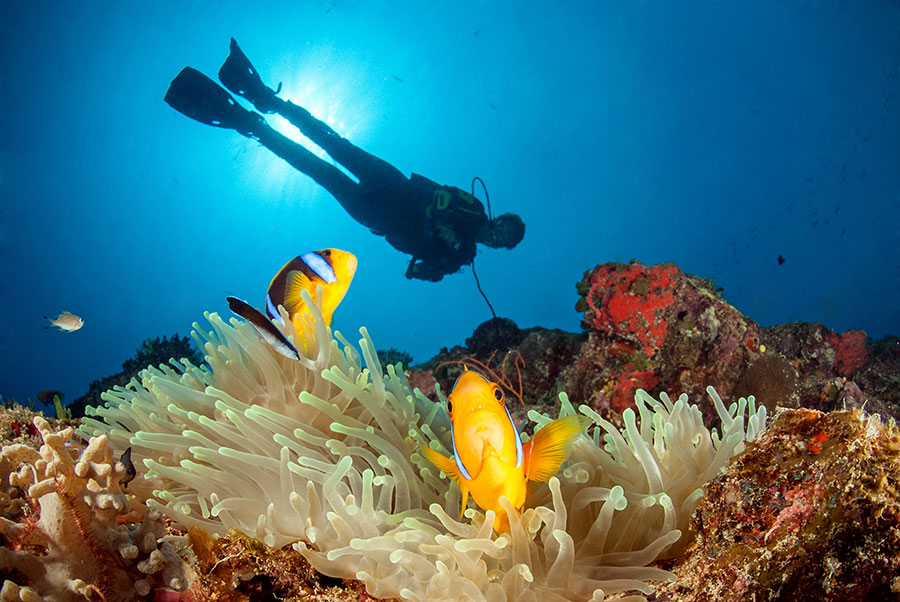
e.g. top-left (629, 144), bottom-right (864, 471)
top-left (656, 409), bottom-right (900, 602)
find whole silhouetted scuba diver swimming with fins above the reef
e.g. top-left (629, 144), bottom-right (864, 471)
top-left (165, 38), bottom-right (525, 282)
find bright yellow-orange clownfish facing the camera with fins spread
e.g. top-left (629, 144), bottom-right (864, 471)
top-left (423, 369), bottom-right (591, 533)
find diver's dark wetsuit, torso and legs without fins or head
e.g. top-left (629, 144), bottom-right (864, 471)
top-left (252, 101), bottom-right (487, 282)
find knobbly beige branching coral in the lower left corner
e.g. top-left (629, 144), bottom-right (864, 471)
top-left (0, 416), bottom-right (191, 602)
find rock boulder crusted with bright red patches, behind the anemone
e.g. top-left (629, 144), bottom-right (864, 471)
top-left (563, 261), bottom-right (760, 419)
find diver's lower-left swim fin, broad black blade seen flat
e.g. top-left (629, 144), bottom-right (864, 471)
top-left (166, 67), bottom-right (265, 136)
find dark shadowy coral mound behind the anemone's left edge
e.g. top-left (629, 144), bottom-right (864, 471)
top-left (69, 332), bottom-right (203, 416)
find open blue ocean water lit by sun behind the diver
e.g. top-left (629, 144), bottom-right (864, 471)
top-left (0, 0), bottom-right (900, 410)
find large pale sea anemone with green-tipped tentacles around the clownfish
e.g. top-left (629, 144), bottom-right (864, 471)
top-left (82, 292), bottom-right (765, 602)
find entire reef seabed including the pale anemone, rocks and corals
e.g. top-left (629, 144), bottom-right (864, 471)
top-left (7, 262), bottom-right (900, 602)
